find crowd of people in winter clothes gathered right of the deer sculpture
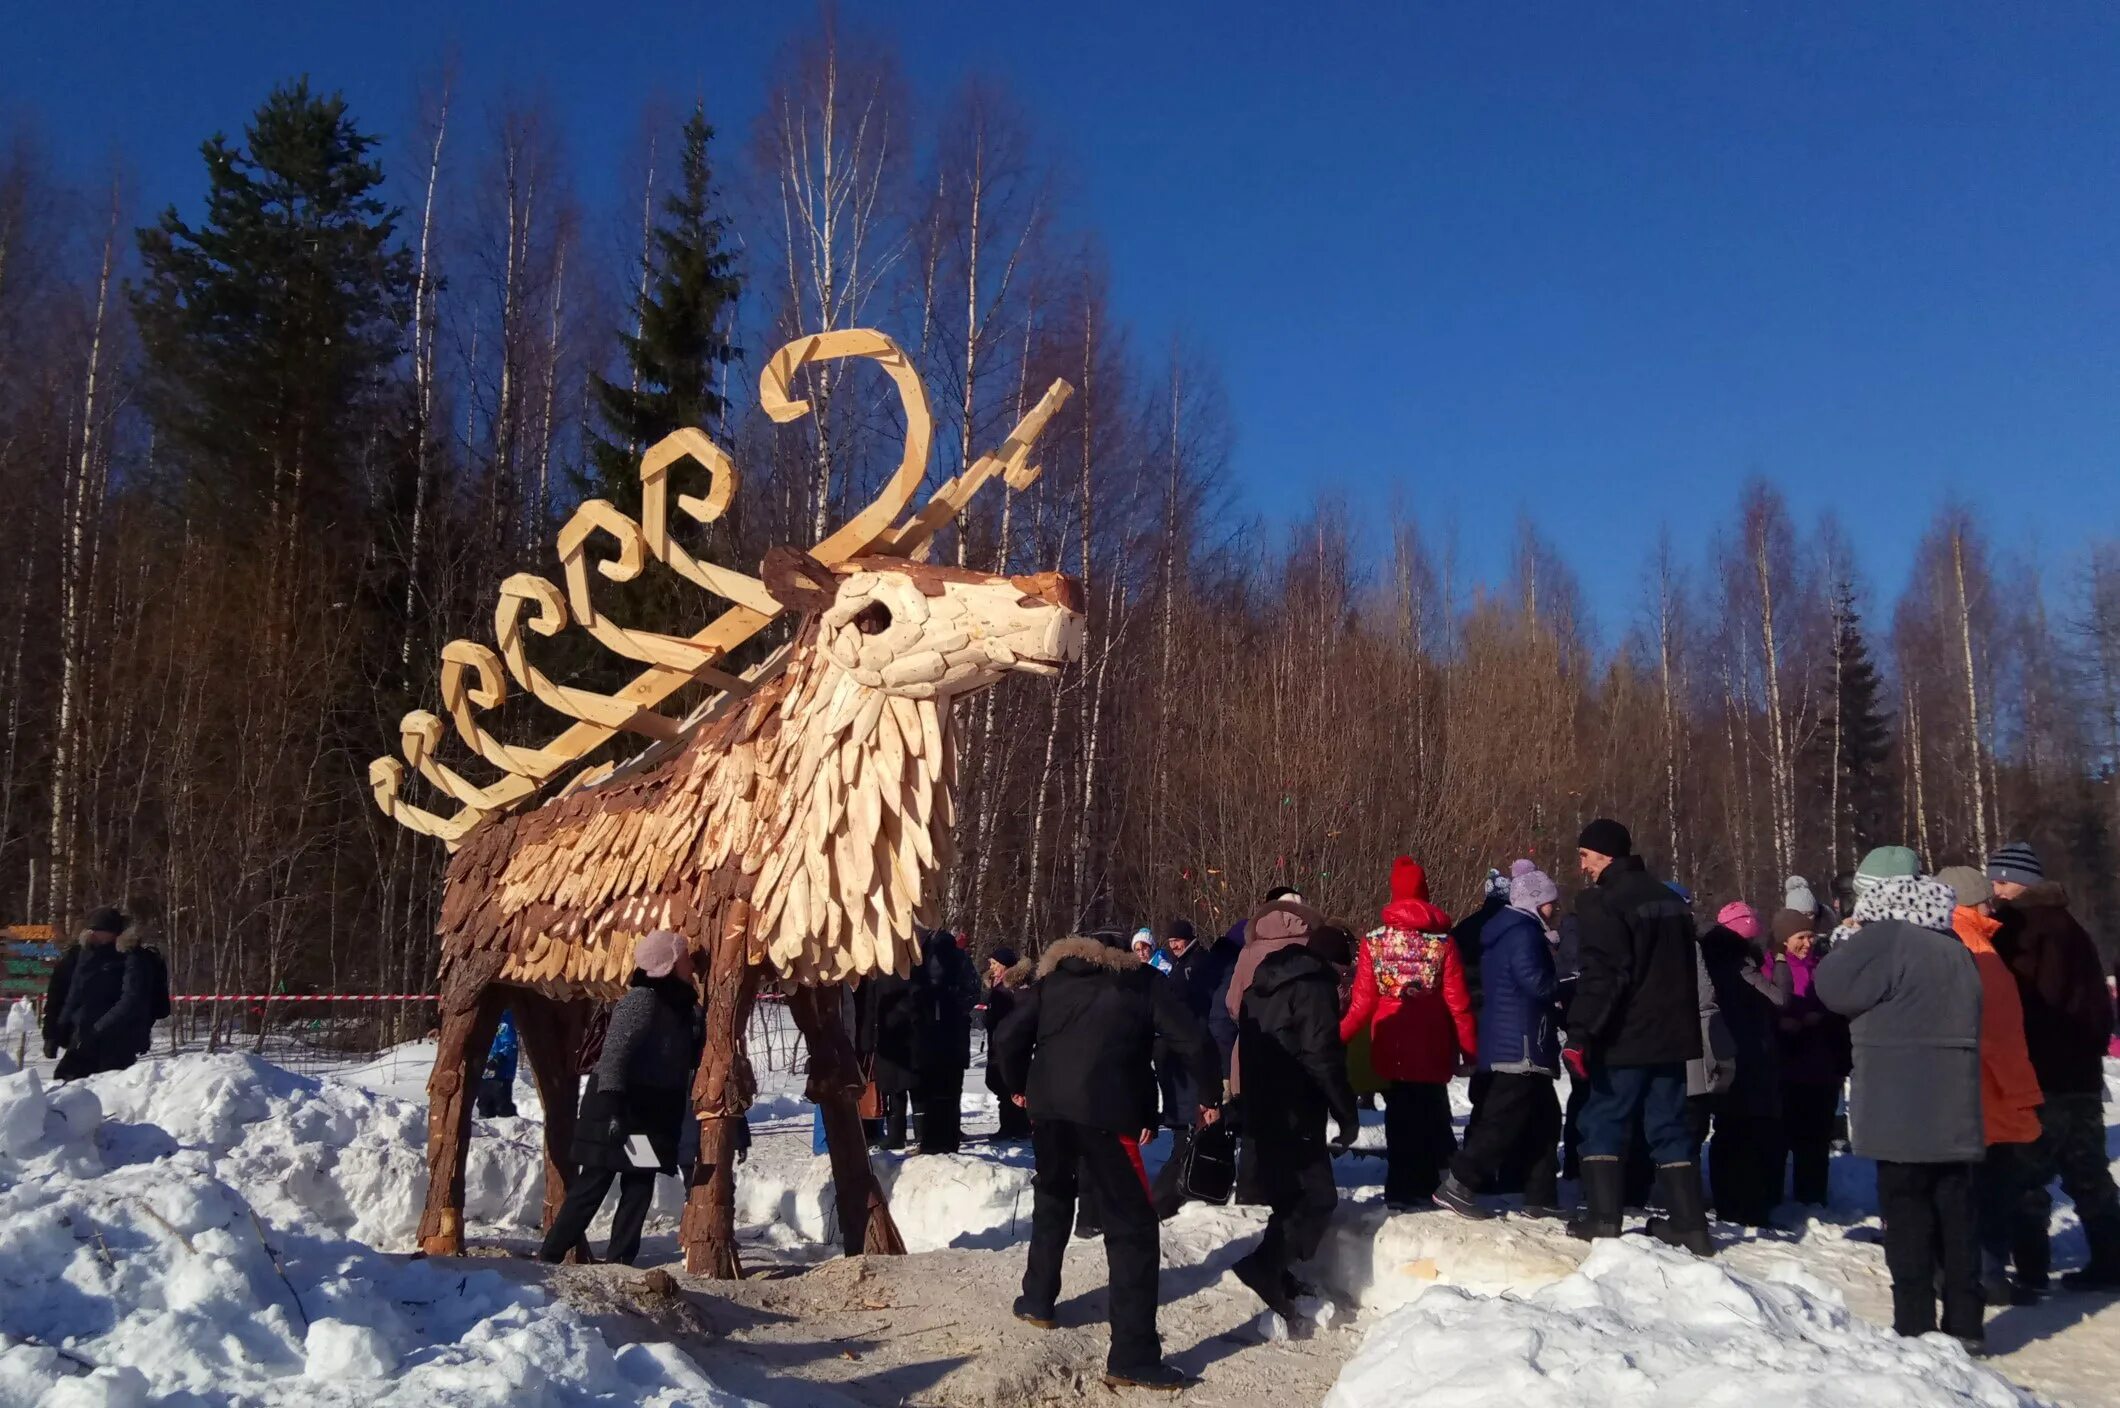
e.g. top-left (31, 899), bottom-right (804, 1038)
top-left (988, 819), bottom-right (2120, 1389)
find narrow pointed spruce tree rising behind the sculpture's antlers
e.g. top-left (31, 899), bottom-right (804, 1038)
top-left (583, 104), bottom-right (740, 513)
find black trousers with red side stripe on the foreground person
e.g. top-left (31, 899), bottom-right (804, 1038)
top-left (1024, 1120), bottom-right (1164, 1370)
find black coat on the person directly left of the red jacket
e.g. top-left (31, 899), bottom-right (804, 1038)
top-left (1236, 946), bottom-right (1361, 1149)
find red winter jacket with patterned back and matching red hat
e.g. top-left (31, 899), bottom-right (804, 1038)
top-left (1340, 857), bottom-right (1480, 1086)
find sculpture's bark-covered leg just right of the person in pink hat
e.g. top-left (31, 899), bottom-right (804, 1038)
top-left (678, 933), bottom-right (757, 1281)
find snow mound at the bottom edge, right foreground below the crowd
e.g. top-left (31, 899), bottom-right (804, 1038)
top-left (1325, 1238), bottom-right (2037, 1408)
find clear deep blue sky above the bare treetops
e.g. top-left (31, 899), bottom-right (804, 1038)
top-left (0, 0), bottom-right (2120, 638)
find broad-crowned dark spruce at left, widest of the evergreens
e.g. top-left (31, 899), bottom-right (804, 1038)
top-left (131, 81), bottom-right (413, 536)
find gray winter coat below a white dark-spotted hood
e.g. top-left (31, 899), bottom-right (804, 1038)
top-left (1810, 918), bottom-right (1986, 1164)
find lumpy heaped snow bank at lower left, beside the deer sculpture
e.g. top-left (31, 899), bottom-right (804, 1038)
top-left (0, 1056), bottom-right (744, 1408)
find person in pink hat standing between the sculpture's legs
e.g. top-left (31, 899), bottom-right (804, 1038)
top-left (538, 929), bottom-right (704, 1266)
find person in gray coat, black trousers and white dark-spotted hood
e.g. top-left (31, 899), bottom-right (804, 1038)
top-left (1813, 876), bottom-right (1986, 1353)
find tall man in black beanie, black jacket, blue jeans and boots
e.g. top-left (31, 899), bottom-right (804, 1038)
top-left (1562, 816), bottom-right (1715, 1255)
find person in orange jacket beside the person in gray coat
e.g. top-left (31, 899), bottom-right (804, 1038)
top-left (1936, 865), bottom-right (2046, 1306)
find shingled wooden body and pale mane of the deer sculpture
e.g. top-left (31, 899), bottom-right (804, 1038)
top-left (441, 621), bottom-right (956, 988)
